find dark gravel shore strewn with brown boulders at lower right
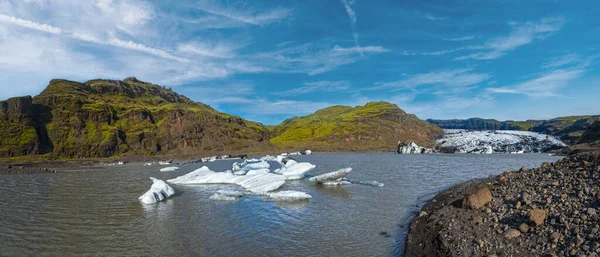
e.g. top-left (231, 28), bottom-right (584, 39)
top-left (405, 152), bottom-right (600, 257)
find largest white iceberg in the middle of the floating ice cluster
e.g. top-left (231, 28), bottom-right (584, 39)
top-left (168, 166), bottom-right (285, 194)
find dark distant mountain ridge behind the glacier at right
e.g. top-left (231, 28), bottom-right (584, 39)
top-left (427, 115), bottom-right (600, 145)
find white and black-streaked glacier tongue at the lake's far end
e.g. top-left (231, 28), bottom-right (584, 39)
top-left (436, 129), bottom-right (566, 154)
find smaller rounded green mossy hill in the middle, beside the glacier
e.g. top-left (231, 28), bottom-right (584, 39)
top-left (270, 102), bottom-right (442, 151)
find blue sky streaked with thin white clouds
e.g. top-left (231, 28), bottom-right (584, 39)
top-left (0, 0), bottom-right (600, 124)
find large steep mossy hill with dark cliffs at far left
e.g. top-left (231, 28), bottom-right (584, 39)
top-left (0, 78), bottom-right (272, 158)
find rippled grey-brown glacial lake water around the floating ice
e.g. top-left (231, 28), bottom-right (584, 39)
top-left (0, 154), bottom-right (558, 256)
